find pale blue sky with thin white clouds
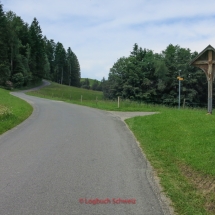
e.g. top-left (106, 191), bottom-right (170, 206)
top-left (0, 0), bottom-right (215, 80)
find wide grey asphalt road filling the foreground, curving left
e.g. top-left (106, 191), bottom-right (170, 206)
top-left (0, 93), bottom-right (170, 215)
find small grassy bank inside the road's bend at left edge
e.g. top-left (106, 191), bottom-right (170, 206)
top-left (0, 89), bottom-right (33, 134)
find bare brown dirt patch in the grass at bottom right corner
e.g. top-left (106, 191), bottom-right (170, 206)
top-left (180, 165), bottom-right (215, 214)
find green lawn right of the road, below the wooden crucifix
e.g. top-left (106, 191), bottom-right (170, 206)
top-left (126, 109), bottom-right (215, 215)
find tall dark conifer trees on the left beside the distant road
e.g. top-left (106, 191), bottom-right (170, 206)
top-left (0, 2), bottom-right (81, 88)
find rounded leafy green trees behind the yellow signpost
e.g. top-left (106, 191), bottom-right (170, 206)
top-left (103, 44), bottom-right (210, 106)
